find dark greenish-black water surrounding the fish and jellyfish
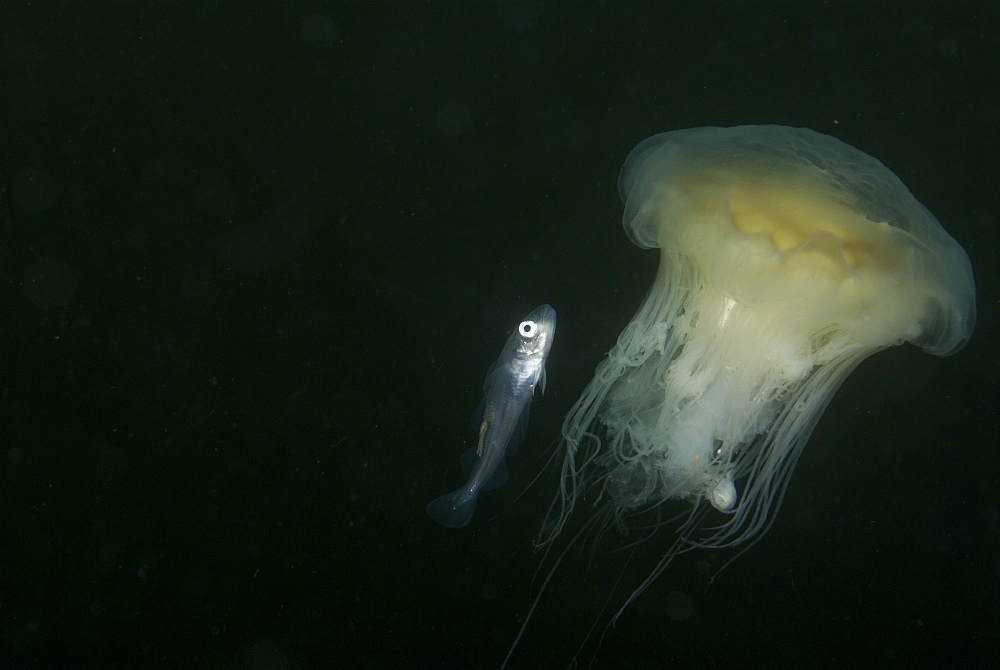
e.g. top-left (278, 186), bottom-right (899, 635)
top-left (0, 0), bottom-right (1000, 670)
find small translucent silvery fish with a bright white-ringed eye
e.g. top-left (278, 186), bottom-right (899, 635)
top-left (424, 305), bottom-right (556, 528)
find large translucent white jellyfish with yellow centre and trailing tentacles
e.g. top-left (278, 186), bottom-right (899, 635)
top-left (546, 125), bottom-right (975, 618)
